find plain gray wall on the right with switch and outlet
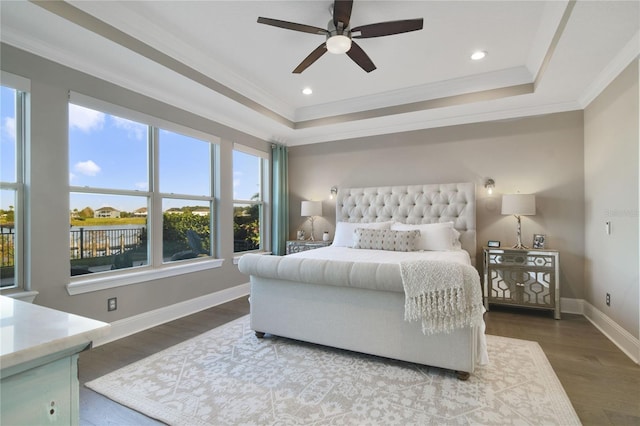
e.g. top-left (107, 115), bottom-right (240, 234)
top-left (584, 60), bottom-right (640, 339)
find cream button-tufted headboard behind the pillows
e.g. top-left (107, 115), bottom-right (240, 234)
top-left (336, 182), bottom-right (476, 265)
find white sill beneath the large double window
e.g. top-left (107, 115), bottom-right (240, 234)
top-left (67, 259), bottom-right (224, 296)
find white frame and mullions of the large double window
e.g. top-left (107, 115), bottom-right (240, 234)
top-left (67, 92), bottom-right (223, 295)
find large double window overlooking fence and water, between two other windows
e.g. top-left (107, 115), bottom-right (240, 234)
top-left (69, 95), bottom-right (215, 275)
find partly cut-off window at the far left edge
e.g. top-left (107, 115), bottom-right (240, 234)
top-left (0, 80), bottom-right (27, 289)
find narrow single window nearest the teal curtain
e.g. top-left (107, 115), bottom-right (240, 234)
top-left (233, 145), bottom-right (267, 253)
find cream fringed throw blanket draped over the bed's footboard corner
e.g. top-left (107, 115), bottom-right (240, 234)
top-left (400, 260), bottom-right (484, 335)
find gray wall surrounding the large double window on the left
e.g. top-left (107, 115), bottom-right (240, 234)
top-left (0, 45), bottom-right (270, 322)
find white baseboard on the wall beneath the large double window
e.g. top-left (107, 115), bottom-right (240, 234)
top-left (93, 283), bottom-right (250, 347)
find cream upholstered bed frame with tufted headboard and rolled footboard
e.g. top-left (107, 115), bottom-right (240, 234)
top-left (240, 183), bottom-right (482, 378)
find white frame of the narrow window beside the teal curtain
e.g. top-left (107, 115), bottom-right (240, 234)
top-left (232, 143), bottom-right (271, 258)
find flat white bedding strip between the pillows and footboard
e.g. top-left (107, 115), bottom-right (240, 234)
top-left (288, 246), bottom-right (471, 265)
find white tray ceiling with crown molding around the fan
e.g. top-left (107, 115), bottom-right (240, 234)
top-left (0, 0), bottom-right (640, 145)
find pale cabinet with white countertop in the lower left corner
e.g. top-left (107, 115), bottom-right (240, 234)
top-left (0, 296), bottom-right (110, 426)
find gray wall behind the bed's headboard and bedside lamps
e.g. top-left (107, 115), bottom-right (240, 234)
top-left (289, 111), bottom-right (584, 299)
